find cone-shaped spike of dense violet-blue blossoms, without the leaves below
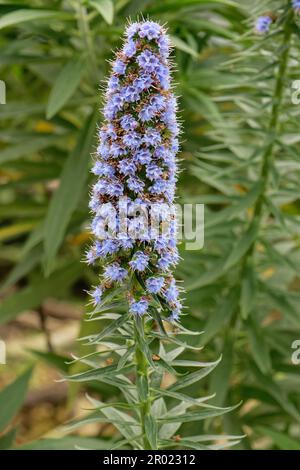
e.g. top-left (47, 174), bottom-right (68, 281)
top-left (87, 21), bottom-right (181, 320)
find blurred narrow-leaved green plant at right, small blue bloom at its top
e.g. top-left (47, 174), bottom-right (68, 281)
top-left (180, 2), bottom-right (300, 448)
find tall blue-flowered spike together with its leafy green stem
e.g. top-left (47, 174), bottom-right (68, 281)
top-left (63, 21), bottom-right (239, 450)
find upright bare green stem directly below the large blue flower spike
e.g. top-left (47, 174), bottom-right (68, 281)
top-left (134, 318), bottom-right (153, 450)
